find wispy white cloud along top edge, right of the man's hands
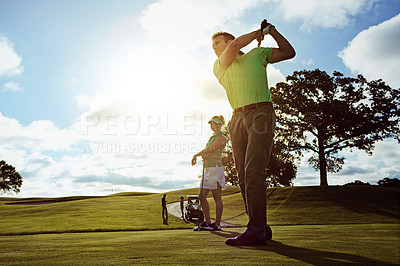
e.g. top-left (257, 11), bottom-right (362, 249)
top-left (273, 0), bottom-right (378, 31)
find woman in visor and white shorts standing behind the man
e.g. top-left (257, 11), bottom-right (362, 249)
top-left (192, 115), bottom-right (226, 230)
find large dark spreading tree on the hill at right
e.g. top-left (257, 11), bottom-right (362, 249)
top-left (271, 69), bottom-right (400, 186)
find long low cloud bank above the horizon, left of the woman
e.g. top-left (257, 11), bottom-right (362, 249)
top-left (0, 109), bottom-right (205, 197)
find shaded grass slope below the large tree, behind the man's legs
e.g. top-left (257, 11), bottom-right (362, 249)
top-left (216, 186), bottom-right (400, 225)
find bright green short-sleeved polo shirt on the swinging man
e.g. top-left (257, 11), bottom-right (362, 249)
top-left (213, 47), bottom-right (272, 108)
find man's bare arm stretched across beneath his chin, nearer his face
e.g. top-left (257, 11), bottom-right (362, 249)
top-left (219, 30), bottom-right (261, 66)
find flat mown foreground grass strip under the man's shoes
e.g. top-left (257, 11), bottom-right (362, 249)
top-left (0, 224), bottom-right (400, 265)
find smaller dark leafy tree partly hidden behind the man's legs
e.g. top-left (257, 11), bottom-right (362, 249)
top-left (221, 131), bottom-right (297, 187)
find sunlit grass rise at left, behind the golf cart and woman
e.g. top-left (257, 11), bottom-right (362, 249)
top-left (0, 187), bottom-right (239, 235)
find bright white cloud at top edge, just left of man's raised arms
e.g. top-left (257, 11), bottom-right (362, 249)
top-left (140, 0), bottom-right (261, 51)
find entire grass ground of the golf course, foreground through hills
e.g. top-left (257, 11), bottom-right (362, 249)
top-left (0, 186), bottom-right (400, 265)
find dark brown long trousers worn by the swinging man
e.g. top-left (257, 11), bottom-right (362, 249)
top-left (228, 105), bottom-right (276, 237)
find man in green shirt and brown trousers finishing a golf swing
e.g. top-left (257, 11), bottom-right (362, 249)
top-left (212, 20), bottom-right (296, 245)
